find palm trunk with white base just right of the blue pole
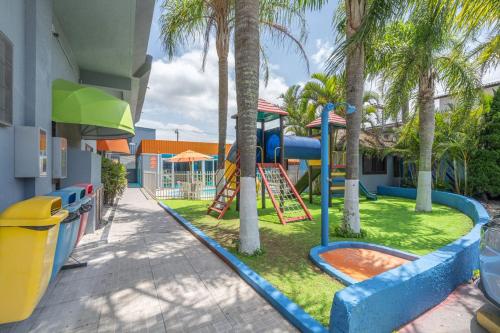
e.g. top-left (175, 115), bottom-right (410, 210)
top-left (343, 0), bottom-right (366, 233)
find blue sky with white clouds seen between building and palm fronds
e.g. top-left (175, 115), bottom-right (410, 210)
top-left (137, 1), bottom-right (500, 143)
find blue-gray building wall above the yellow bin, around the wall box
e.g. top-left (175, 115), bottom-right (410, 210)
top-left (0, 0), bottom-right (78, 210)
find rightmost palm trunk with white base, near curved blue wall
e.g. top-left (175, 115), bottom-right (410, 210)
top-left (415, 69), bottom-right (435, 212)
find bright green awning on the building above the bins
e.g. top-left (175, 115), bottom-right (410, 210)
top-left (52, 80), bottom-right (135, 139)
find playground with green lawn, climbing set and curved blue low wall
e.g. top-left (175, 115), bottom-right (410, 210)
top-left (159, 100), bottom-right (487, 331)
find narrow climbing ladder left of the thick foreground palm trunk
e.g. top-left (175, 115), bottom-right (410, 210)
top-left (207, 154), bottom-right (240, 220)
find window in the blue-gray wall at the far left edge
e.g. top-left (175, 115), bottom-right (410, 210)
top-left (0, 31), bottom-right (12, 126)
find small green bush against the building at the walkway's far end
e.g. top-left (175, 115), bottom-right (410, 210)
top-left (101, 157), bottom-right (127, 204)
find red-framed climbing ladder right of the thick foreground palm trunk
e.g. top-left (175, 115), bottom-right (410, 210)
top-left (257, 163), bottom-right (312, 224)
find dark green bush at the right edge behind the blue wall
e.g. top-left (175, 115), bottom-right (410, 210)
top-left (470, 89), bottom-right (500, 197)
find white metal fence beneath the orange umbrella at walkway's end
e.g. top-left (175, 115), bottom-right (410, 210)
top-left (143, 170), bottom-right (216, 200)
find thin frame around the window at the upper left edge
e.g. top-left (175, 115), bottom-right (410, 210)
top-left (0, 31), bottom-right (14, 127)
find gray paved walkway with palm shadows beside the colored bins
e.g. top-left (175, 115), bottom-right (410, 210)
top-left (0, 188), bottom-right (295, 333)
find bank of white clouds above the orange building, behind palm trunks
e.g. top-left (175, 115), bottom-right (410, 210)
top-left (138, 43), bottom-right (288, 142)
